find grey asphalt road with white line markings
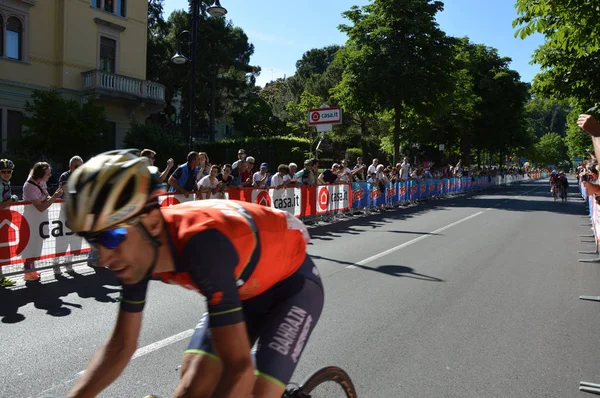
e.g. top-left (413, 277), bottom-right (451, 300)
top-left (0, 182), bottom-right (600, 398)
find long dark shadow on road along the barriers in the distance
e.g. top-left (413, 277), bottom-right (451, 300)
top-left (310, 181), bottom-right (587, 241)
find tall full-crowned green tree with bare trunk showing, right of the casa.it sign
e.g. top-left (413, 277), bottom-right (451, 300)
top-left (339, 0), bottom-right (452, 162)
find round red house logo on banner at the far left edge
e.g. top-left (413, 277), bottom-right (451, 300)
top-left (0, 210), bottom-right (31, 259)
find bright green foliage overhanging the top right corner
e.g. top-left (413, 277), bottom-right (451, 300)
top-left (513, 0), bottom-right (600, 107)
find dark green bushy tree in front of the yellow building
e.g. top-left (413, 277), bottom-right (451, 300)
top-left (17, 90), bottom-right (109, 164)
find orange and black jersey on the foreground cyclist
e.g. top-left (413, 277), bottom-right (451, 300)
top-left (121, 200), bottom-right (306, 327)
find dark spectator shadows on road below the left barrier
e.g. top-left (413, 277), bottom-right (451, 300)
top-left (0, 268), bottom-right (121, 323)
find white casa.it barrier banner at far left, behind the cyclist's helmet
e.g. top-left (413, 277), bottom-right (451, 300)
top-left (0, 204), bottom-right (91, 266)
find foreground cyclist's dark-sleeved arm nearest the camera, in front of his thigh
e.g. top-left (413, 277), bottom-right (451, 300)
top-left (184, 229), bottom-right (255, 397)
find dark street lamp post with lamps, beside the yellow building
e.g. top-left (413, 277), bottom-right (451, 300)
top-left (171, 0), bottom-right (227, 151)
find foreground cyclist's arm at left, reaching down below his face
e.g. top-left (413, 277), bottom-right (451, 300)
top-left (68, 279), bottom-right (149, 398)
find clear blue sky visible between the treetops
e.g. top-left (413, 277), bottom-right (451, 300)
top-left (164, 0), bottom-right (543, 86)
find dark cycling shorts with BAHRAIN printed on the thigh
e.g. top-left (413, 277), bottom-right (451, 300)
top-left (185, 255), bottom-right (324, 388)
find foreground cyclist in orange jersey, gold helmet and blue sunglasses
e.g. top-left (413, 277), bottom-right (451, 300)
top-left (65, 151), bottom-right (324, 397)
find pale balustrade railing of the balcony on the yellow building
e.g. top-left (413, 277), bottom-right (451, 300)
top-left (82, 70), bottom-right (165, 102)
